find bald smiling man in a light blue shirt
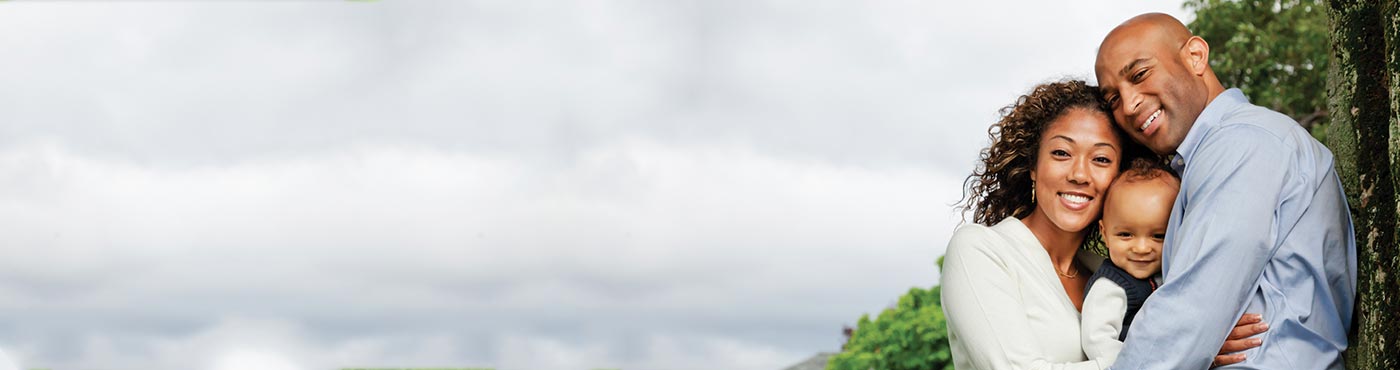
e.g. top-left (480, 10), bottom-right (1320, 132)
top-left (1095, 14), bottom-right (1357, 370)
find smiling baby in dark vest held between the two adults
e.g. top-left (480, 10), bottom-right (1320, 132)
top-left (1079, 158), bottom-right (1182, 363)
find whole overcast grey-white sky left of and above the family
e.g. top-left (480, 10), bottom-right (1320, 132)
top-left (0, 0), bottom-right (1187, 370)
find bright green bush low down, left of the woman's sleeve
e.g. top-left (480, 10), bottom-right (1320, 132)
top-left (826, 258), bottom-right (953, 370)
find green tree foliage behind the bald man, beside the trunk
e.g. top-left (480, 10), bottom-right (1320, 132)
top-left (1186, 0), bottom-right (1329, 127)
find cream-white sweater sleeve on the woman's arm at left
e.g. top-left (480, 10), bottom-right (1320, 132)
top-left (941, 227), bottom-right (1106, 370)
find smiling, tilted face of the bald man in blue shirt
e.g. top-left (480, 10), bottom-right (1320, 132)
top-left (1093, 27), bottom-right (1207, 156)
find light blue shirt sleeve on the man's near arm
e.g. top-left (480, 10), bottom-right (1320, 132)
top-left (1113, 125), bottom-right (1295, 370)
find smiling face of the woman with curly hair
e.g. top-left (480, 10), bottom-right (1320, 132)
top-left (1030, 108), bottom-right (1123, 233)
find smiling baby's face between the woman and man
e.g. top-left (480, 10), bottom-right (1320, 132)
top-left (1099, 174), bottom-right (1177, 279)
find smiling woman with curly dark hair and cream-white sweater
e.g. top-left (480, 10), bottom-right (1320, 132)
top-left (941, 81), bottom-right (1259, 370)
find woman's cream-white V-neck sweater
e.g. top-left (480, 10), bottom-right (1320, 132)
top-left (941, 217), bottom-right (1109, 370)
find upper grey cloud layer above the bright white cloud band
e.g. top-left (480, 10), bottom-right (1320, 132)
top-left (0, 1), bottom-right (1179, 171)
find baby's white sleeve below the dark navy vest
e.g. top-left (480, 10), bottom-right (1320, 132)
top-left (1079, 280), bottom-right (1128, 363)
